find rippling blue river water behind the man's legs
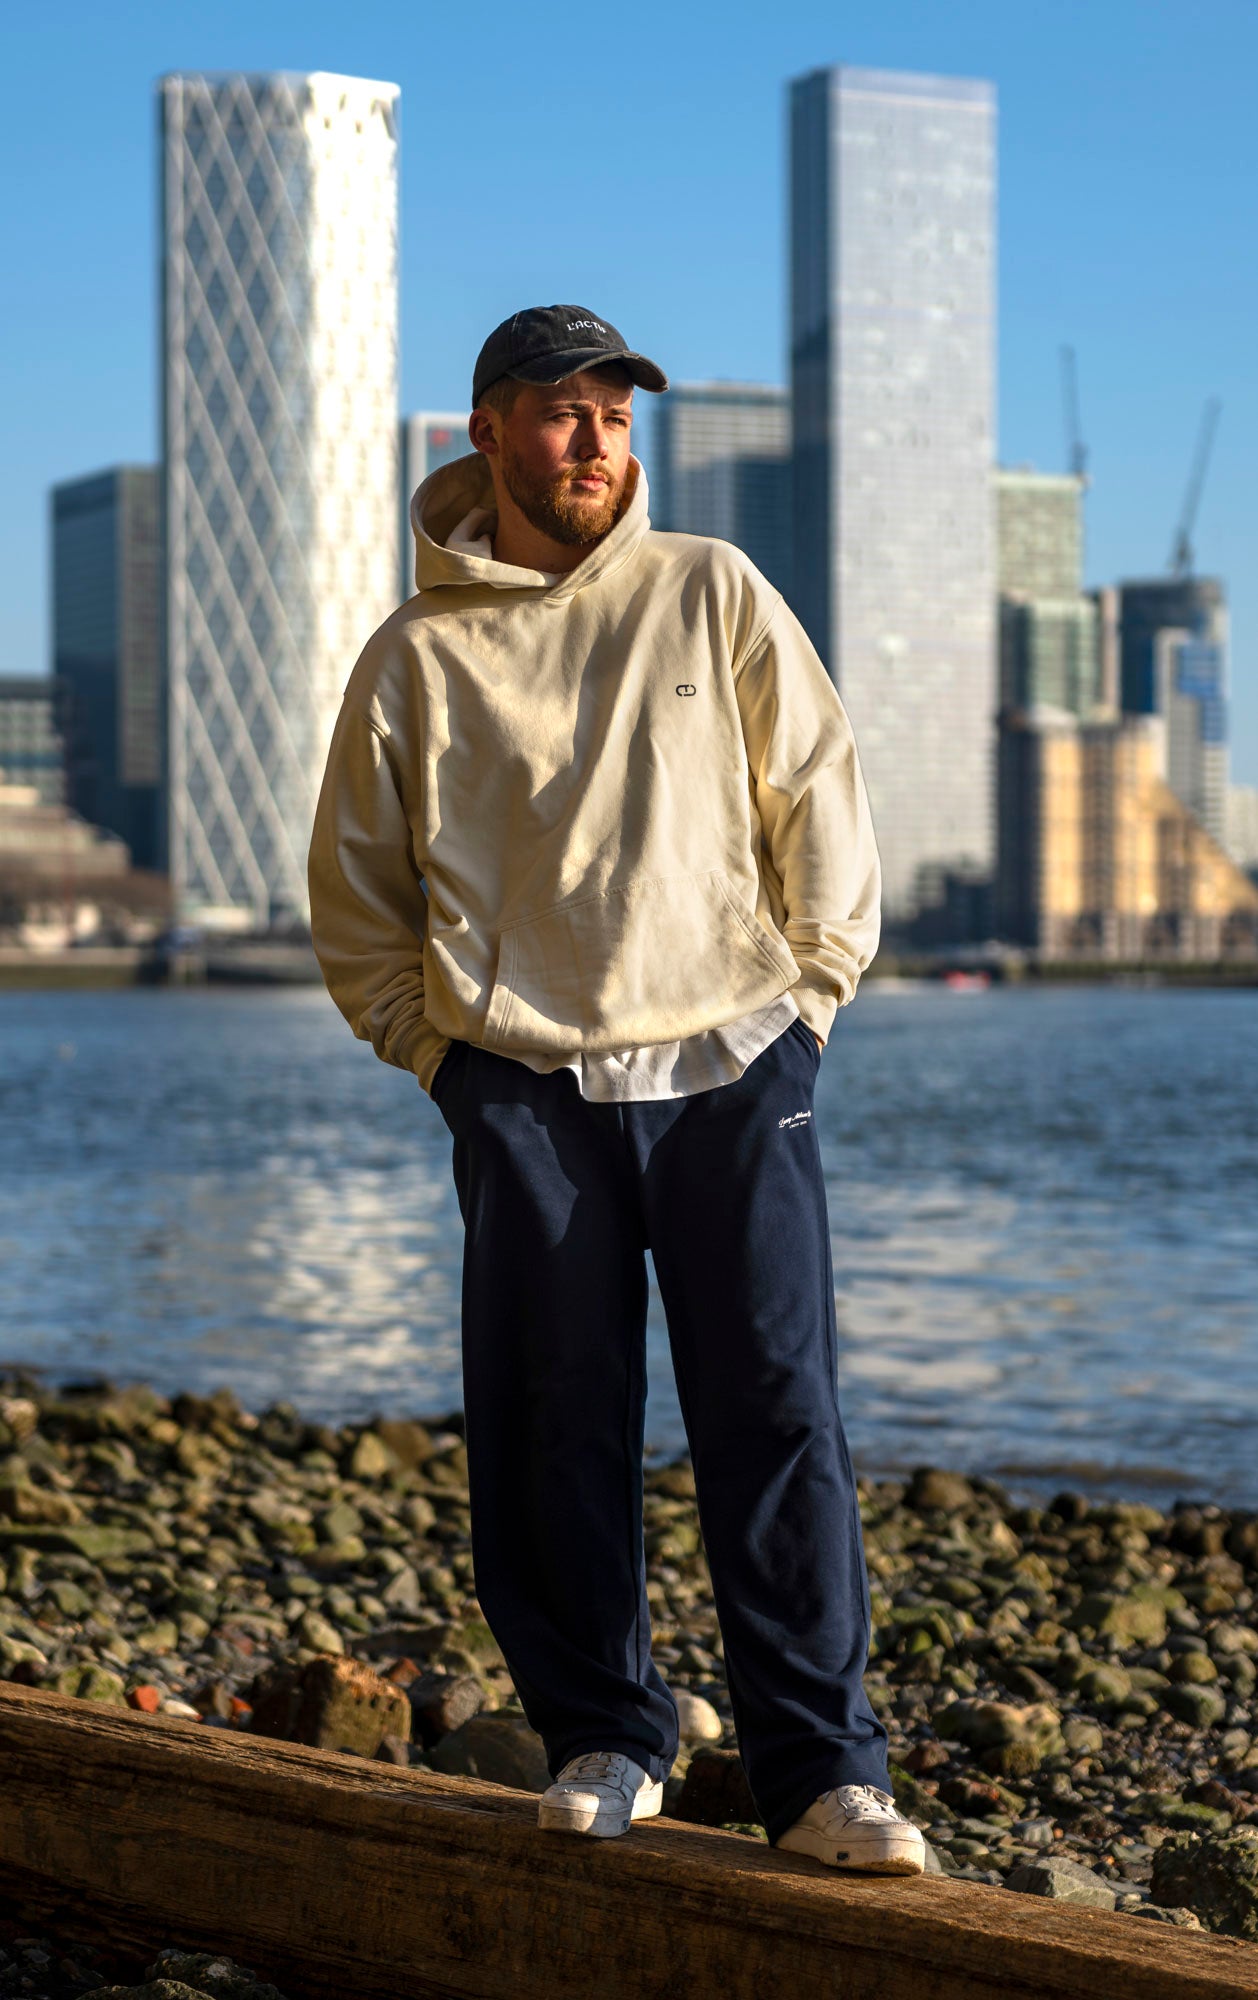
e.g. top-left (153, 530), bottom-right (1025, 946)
top-left (0, 986), bottom-right (1258, 1506)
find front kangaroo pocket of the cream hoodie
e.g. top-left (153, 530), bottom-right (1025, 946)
top-left (484, 870), bottom-right (798, 1054)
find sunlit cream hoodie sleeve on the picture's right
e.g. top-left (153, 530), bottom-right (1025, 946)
top-left (734, 598), bottom-right (882, 1040)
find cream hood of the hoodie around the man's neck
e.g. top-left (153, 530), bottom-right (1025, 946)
top-left (410, 452), bottom-right (650, 598)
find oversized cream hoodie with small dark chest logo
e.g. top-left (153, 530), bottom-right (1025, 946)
top-left (310, 454), bottom-right (880, 1088)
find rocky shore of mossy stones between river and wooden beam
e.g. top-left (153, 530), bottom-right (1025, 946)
top-left (0, 1374), bottom-right (1258, 2000)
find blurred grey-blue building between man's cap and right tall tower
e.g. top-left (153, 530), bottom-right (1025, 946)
top-left (650, 382), bottom-right (790, 592)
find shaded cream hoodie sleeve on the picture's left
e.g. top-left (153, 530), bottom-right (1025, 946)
top-left (310, 702), bottom-right (450, 1090)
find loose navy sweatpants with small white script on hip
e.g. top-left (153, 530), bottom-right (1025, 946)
top-left (434, 1020), bottom-right (888, 1840)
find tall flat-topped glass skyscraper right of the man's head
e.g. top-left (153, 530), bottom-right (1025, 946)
top-left (790, 68), bottom-right (996, 924)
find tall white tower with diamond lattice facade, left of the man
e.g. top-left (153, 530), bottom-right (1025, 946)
top-left (158, 72), bottom-right (398, 928)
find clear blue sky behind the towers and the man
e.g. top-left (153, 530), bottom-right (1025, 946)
top-left (0, 0), bottom-right (1258, 784)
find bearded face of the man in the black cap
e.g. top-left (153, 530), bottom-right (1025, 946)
top-left (498, 368), bottom-right (634, 548)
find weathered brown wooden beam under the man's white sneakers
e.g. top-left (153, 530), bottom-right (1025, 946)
top-left (0, 1684), bottom-right (1258, 2000)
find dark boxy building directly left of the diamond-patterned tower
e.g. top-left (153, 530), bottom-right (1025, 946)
top-left (52, 466), bottom-right (166, 868)
